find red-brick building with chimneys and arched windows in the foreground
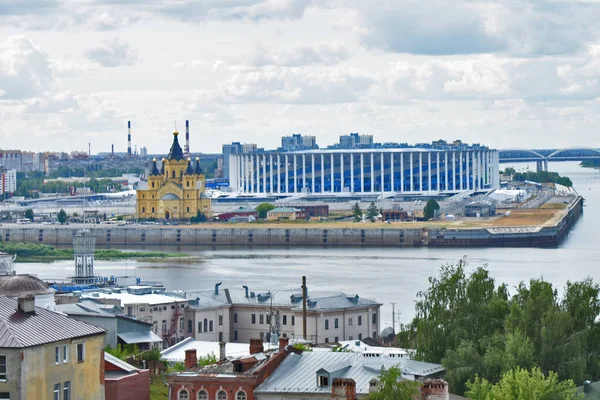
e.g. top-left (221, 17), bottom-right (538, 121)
top-left (167, 338), bottom-right (297, 400)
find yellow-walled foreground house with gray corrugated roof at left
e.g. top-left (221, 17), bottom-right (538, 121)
top-left (0, 295), bottom-right (105, 400)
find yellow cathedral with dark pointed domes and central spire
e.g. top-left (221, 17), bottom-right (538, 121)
top-left (136, 129), bottom-right (211, 220)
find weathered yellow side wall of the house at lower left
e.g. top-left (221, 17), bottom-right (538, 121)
top-left (16, 334), bottom-right (104, 400)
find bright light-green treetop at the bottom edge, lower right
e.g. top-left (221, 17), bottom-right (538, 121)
top-left (466, 368), bottom-right (580, 400)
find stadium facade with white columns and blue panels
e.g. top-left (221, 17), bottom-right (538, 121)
top-left (229, 148), bottom-right (500, 195)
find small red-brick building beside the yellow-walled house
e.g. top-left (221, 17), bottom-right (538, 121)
top-left (104, 352), bottom-right (150, 400)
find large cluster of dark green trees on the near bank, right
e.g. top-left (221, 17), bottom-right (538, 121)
top-left (398, 260), bottom-right (600, 394)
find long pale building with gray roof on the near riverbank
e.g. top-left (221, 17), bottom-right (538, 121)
top-left (184, 284), bottom-right (382, 343)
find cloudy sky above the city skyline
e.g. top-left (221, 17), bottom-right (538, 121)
top-left (0, 0), bottom-right (600, 153)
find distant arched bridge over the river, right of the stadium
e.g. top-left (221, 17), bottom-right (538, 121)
top-left (499, 147), bottom-right (600, 172)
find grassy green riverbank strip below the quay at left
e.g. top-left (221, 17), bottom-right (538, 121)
top-left (0, 243), bottom-right (188, 263)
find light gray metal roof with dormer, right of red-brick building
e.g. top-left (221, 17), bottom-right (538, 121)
top-left (255, 351), bottom-right (444, 394)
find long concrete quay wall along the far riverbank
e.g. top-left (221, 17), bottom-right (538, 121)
top-left (0, 197), bottom-right (583, 247)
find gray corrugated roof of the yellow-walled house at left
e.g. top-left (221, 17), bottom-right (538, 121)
top-left (0, 296), bottom-right (105, 348)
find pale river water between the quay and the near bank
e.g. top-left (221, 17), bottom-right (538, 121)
top-left (17, 162), bottom-right (600, 329)
